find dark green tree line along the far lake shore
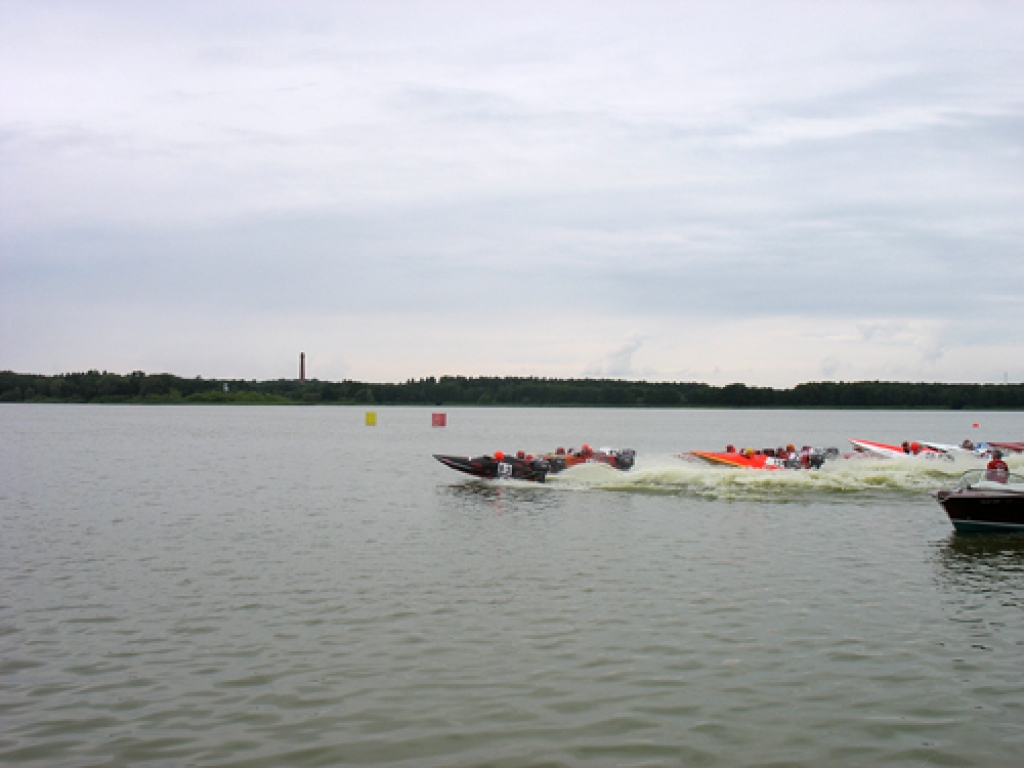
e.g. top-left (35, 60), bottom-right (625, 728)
top-left (0, 371), bottom-right (1024, 410)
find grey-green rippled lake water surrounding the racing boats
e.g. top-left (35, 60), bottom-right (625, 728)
top-left (0, 404), bottom-right (1024, 767)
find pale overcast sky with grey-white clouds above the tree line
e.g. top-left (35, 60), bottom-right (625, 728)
top-left (0, 0), bottom-right (1024, 386)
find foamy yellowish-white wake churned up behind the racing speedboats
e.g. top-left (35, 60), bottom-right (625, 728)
top-left (548, 456), bottom-right (1024, 503)
